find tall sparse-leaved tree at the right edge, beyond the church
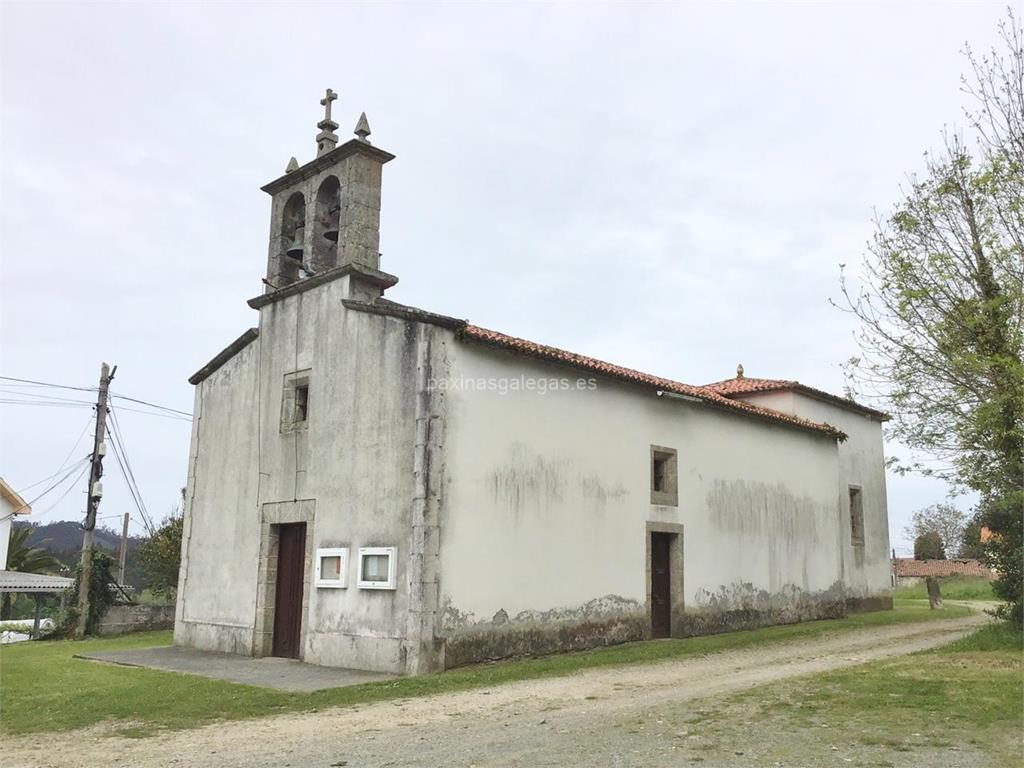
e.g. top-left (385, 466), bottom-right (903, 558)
top-left (842, 11), bottom-right (1024, 624)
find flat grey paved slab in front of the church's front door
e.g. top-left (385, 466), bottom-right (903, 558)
top-left (75, 645), bottom-right (396, 693)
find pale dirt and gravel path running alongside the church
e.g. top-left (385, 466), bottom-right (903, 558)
top-left (6, 614), bottom-right (987, 768)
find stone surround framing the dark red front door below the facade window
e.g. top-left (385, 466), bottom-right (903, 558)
top-left (253, 499), bottom-right (316, 659)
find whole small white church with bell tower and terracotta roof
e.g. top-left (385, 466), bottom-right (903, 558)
top-left (174, 92), bottom-right (891, 674)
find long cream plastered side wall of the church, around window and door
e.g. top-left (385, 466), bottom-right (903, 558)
top-left (441, 343), bottom-right (842, 651)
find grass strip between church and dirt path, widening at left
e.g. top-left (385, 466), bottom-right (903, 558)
top-left (0, 601), bottom-right (970, 736)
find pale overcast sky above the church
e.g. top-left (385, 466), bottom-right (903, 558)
top-left (0, 2), bottom-right (1005, 548)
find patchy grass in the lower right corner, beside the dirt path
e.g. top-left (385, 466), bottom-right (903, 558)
top-left (676, 624), bottom-right (1024, 768)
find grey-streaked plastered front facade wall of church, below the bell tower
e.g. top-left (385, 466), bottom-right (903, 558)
top-left (175, 280), bottom-right (432, 672)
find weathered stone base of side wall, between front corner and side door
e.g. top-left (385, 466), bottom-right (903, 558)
top-left (443, 615), bottom-right (650, 670)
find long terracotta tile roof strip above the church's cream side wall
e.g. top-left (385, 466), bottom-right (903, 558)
top-left (460, 324), bottom-right (846, 440)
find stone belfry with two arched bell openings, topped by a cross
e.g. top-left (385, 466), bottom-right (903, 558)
top-left (263, 88), bottom-right (397, 299)
